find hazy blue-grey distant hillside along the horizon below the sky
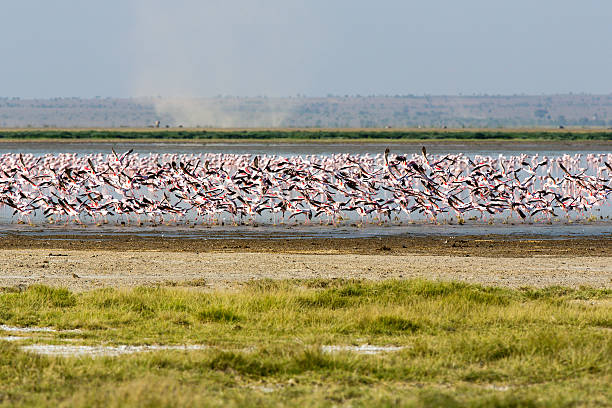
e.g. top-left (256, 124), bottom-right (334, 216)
top-left (0, 94), bottom-right (612, 128)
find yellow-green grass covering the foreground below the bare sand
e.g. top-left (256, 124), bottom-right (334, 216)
top-left (0, 280), bottom-right (612, 407)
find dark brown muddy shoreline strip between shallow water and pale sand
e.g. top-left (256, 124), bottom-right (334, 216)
top-left (0, 234), bottom-right (612, 258)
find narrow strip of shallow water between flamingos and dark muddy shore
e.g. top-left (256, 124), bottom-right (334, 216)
top-left (0, 222), bottom-right (612, 239)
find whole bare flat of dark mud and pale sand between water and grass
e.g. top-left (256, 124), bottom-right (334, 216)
top-left (0, 235), bottom-right (612, 291)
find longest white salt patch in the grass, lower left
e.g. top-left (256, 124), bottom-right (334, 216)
top-left (23, 344), bottom-right (207, 357)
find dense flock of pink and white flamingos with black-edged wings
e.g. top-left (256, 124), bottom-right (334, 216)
top-left (0, 148), bottom-right (612, 223)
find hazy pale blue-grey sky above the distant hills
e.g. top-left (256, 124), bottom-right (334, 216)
top-left (0, 0), bottom-right (612, 97)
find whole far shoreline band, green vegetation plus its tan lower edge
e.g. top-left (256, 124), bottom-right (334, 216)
top-left (0, 128), bottom-right (612, 147)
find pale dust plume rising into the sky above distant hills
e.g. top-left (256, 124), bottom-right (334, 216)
top-left (127, 0), bottom-right (319, 127)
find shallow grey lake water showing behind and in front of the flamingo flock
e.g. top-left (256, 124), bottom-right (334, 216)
top-left (0, 141), bottom-right (612, 239)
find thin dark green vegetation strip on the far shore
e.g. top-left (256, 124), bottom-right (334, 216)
top-left (0, 129), bottom-right (612, 140)
